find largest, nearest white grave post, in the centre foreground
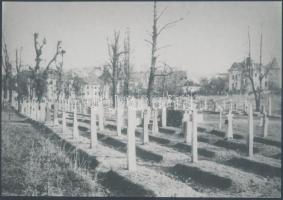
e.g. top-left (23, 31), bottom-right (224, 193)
top-left (127, 107), bottom-right (136, 171)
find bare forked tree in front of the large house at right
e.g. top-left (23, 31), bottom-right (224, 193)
top-left (243, 26), bottom-right (275, 112)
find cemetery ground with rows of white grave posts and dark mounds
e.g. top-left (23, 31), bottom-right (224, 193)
top-left (2, 96), bottom-right (281, 197)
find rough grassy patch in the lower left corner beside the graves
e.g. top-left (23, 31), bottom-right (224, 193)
top-left (1, 118), bottom-right (103, 196)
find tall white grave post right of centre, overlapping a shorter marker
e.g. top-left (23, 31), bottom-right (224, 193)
top-left (192, 109), bottom-right (198, 163)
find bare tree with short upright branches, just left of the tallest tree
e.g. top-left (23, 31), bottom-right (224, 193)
top-left (108, 31), bottom-right (125, 107)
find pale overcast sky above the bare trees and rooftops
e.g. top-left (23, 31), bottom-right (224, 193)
top-left (2, 2), bottom-right (282, 78)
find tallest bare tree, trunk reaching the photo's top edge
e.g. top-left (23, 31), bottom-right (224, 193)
top-left (145, 1), bottom-right (183, 106)
